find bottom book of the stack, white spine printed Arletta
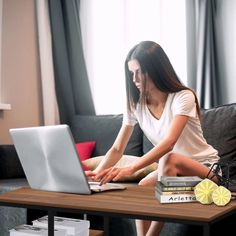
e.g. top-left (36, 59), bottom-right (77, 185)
top-left (155, 192), bottom-right (197, 203)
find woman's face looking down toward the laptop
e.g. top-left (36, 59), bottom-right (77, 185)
top-left (128, 60), bottom-right (144, 91)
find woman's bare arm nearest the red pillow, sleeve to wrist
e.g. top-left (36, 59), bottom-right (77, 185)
top-left (94, 125), bottom-right (134, 173)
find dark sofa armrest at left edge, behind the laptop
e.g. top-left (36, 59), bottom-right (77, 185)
top-left (0, 145), bottom-right (25, 179)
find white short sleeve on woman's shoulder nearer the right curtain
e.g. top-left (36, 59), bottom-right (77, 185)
top-left (172, 90), bottom-right (197, 117)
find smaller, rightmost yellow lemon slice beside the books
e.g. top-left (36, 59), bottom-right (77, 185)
top-left (212, 186), bottom-right (231, 206)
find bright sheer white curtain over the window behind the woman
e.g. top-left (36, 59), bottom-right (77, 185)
top-left (80, 0), bottom-right (187, 114)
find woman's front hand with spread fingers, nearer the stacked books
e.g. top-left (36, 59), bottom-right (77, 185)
top-left (95, 166), bottom-right (135, 185)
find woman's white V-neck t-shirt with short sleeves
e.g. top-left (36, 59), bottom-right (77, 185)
top-left (123, 90), bottom-right (219, 164)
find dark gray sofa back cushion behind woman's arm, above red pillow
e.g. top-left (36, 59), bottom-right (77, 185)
top-left (70, 115), bottom-right (143, 156)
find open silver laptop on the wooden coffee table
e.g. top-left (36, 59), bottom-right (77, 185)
top-left (10, 125), bottom-right (125, 194)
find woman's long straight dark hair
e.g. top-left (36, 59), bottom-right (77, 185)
top-left (125, 41), bottom-right (200, 117)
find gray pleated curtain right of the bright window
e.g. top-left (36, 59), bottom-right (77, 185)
top-left (186, 0), bottom-right (221, 108)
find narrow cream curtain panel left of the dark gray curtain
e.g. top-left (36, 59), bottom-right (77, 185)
top-left (36, 0), bottom-right (60, 125)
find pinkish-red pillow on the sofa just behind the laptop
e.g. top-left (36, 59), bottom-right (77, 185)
top-left (75, 141), bottom-right (96, 170)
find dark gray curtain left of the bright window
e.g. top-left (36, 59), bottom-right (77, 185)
top-left (49, 0), bottom-right (95, 123)
